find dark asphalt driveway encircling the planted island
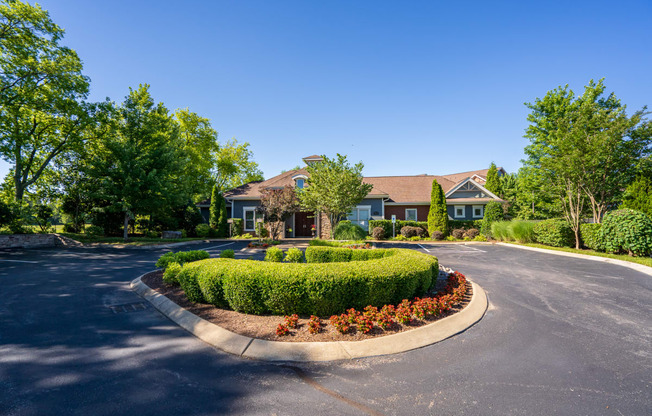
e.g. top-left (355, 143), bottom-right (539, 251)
top-left (0, 242), bottom-right (652, 416)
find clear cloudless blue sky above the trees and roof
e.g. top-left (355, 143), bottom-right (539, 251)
top-left (0, 0), bottom-right (652, 178)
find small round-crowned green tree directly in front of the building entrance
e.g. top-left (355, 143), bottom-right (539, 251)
top-left (297, 153), bottom-right (373, 234)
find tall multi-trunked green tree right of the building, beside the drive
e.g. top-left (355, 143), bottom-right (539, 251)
top-left (524, 80), bottom-right (650, 248)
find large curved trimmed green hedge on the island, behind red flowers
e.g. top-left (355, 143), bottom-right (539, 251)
top-left (177, 247), bottom-right (439, 316)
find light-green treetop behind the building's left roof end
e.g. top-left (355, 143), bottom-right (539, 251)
top-left (213, 139), bottom-right (263, 191)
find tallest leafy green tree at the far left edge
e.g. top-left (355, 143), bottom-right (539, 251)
top-left (0, 0), bottom-right (93, 201)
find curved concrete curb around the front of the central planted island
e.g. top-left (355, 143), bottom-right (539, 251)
top-left (131, 275), bottom-right (489, 362)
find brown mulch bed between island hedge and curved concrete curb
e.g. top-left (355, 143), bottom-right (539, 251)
top-left (142, 271), bottom-right (472, 342)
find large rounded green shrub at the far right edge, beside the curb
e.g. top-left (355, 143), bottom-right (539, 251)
top-left (601, 209), bottom-right (652, 256)
